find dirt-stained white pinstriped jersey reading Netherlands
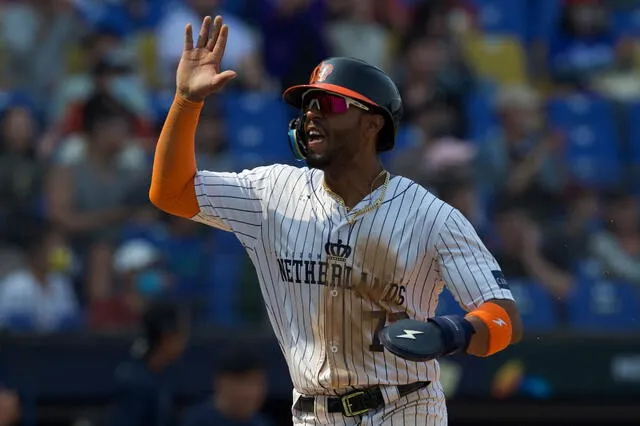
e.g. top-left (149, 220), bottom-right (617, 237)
top-left (193, 164), bottom-right (512, 395)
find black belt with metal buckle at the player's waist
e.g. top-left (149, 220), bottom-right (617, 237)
top-left (294, 382), bottom-right (431, 417)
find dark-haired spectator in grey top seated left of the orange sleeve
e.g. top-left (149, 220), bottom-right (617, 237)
top-left (47, 95), bottom-right (149, 302)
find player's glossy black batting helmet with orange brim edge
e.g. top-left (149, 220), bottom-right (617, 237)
top-left (283, 57), bottom-right (403, 158)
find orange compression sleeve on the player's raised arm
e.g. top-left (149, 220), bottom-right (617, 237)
top-left (149, 95), bottom-right (203, 218)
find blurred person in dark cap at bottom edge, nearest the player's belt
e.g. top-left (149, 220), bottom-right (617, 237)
top-left (181, 342), bottom-right (271, 426)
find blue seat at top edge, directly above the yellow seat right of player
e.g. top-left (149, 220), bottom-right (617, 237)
top-left (471, 0), bottom-right (527, 40)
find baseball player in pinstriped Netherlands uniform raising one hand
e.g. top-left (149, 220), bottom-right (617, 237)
top-left (150, 17), bottom-right (522, 426)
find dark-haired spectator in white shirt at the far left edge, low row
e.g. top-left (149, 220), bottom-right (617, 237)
top-left (0, 225), bottom-right (79, 332)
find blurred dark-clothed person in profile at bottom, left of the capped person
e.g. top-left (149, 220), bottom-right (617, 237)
top-left (108, 303), bottom-right (189, 426)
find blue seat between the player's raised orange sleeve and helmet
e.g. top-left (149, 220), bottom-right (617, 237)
top-left (223, 92), bottom-right (292, 168)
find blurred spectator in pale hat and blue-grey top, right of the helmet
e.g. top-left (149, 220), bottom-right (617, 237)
top-left (476, 86), bottom-right (563, 221)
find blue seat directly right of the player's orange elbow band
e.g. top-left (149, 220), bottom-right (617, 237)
top-left (509, 278), bottom-right (558, 331)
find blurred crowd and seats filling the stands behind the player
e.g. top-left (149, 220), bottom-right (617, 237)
top-left (0, 0), bottom-right (640, 340)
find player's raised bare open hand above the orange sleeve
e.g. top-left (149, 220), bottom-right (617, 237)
top-left (176, 16), bottom-right (237, 102)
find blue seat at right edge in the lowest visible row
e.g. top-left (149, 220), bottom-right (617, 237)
top-left (569, 277), bottom-right (640, 331)
